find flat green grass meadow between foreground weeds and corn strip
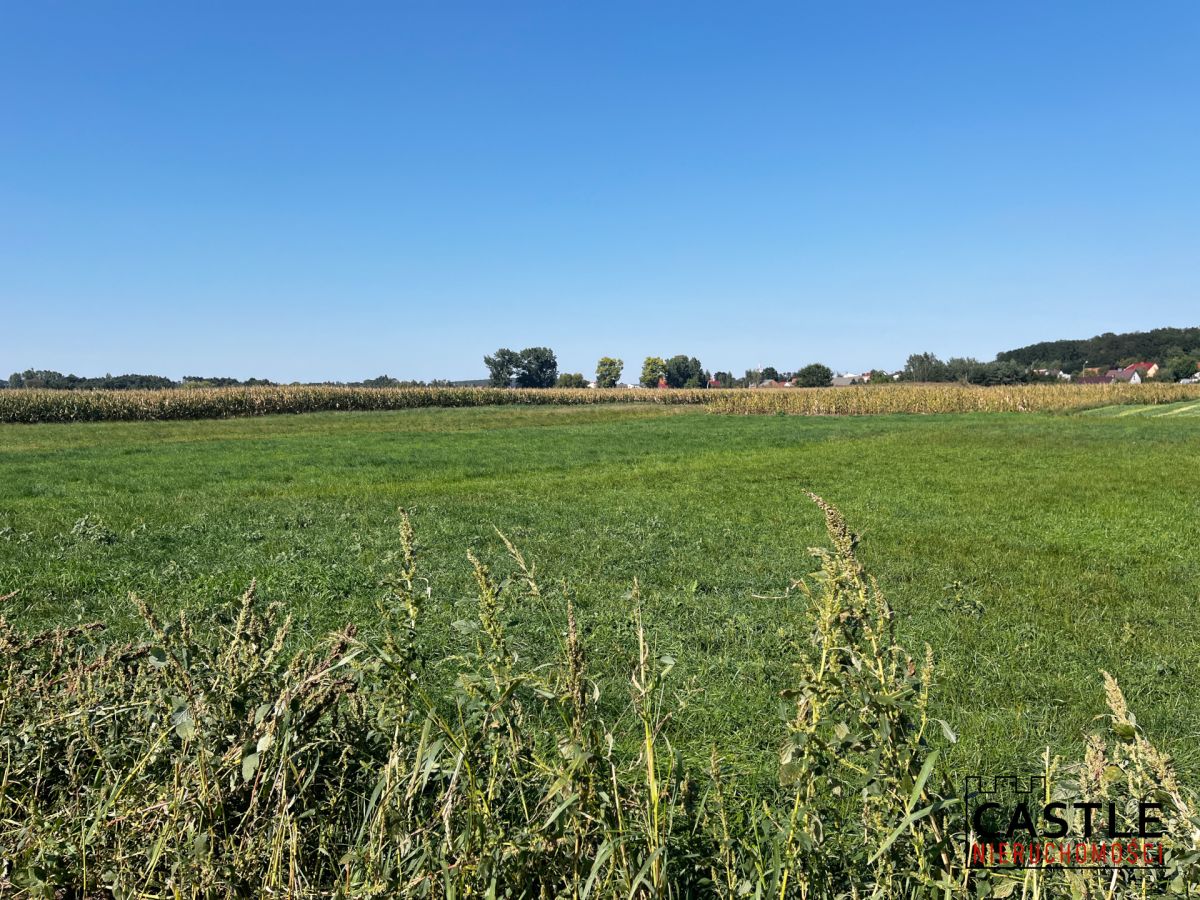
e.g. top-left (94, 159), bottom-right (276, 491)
top-left (0, 403), bottom-right (1200, 776)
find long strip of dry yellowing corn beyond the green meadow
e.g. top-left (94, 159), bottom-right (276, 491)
top-left (0, 384), bottom-right (1200, 424)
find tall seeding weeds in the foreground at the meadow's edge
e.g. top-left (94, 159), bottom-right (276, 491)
top-left (0, 497), bottom-right (1200, 900)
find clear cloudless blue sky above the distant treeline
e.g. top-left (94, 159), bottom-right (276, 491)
top-left (0, 0), bottom-right (1200, 380)
